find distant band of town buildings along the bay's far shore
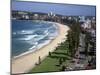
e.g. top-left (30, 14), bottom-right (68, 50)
top-left (12, 11), bottom-right (69, 23)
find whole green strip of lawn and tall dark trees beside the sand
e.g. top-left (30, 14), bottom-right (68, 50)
top-left (29, 18), bottom-right (80, 73)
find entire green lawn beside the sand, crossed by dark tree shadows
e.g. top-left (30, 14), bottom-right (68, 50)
top-left (29, 41), bottom-right (71, 73)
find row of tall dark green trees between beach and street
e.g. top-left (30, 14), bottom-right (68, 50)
top-left (66, 20), bottom-right (81, 56)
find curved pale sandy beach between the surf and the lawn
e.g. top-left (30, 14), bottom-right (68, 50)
top-left (12, 23), bottom-right (69, 74)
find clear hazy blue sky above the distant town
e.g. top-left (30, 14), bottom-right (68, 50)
top-left (12, 1), bottom-right (96, 16)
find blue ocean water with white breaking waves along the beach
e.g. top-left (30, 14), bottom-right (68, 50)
top-left (12, 20), bottom-right (58, 57)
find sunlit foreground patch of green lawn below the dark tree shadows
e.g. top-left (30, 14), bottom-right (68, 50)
top-left (31, 57), bottom-right (59, 72)
